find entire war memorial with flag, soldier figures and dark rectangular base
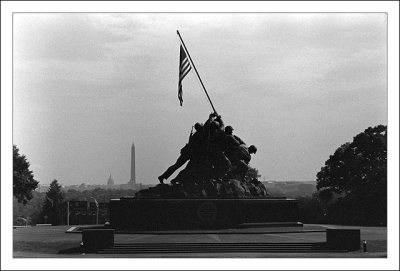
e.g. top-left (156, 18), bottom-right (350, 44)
top-left (110, 32), bottom-right (298, 230)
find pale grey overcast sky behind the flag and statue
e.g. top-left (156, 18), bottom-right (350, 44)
top-left (13, 13), bottom-right (388, 185)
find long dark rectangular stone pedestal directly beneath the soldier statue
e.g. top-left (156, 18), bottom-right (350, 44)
top-left (110, 198), bottom-right (299, 230)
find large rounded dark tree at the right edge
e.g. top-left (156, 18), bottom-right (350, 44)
top-left (317, 125), bottom-right (387, 225)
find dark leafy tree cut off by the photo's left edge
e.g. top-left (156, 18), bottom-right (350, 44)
top-left (13, 145), bottom-right (39, 205)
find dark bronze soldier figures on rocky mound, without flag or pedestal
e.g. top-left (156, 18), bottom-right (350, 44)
top-left (136, 113), bottom-right (268, 198)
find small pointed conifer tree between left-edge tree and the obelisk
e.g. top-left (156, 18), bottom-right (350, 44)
top-left (43, 180), bottom-right (64, 225)
